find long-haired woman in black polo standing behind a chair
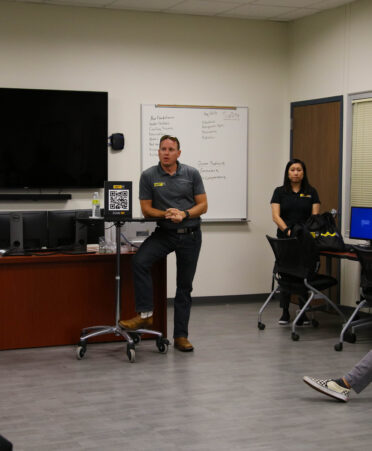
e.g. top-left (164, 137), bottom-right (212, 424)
top-left (271, 158), bottom-right (320, 325)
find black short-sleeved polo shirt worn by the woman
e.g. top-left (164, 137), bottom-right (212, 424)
top-left (270, 186), bottom-right (320, 231)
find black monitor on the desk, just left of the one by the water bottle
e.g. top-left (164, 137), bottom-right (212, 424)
top-left (48, 210), bottom-right (76, 249)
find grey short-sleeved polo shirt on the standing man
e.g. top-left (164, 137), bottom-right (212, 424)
top-left (139, 161), bottom-right (205, 229)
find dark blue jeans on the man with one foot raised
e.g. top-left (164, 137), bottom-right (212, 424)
top-left (133, 227), bottom-right (202, 338)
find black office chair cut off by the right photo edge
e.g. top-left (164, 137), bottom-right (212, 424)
top-left (335, 246), bottom-right (372, 351)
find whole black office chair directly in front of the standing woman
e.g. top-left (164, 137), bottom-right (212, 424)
top-left (258, 234), bottom-right (346, 341)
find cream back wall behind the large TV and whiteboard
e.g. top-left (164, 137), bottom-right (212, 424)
top-left (0, 3), bottom-right (289, 302)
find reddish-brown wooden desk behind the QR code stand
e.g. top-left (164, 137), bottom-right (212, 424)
top-left (0, 253), bottom-right (167, 350)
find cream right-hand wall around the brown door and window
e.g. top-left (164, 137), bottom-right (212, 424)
top-left (289, 0), bottom-right (372, 305)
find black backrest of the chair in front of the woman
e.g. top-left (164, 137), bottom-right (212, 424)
top-left (266, 235), bottom-right (319, 279)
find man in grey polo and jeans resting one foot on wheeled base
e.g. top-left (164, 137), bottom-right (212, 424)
top-left (119, 135), bottom-right (208, 352)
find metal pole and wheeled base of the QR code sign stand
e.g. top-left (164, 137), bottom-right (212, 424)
top-left (76, 222), bottom-right (169, 363)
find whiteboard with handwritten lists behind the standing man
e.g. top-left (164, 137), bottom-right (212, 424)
top-left (141, 105), bottom-right (248, 221)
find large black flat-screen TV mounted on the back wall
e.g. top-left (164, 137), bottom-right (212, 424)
top-left (0, 88), bottom-right (108, 189)
